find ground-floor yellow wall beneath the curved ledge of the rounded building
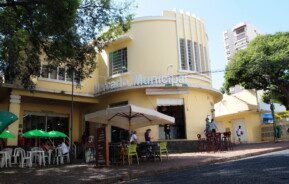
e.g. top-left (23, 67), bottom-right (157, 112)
top-left (91, 89), bottom-right (214, 141)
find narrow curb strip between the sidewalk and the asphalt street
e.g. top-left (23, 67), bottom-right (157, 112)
top-left (94, 146), bottom-right (289, 184)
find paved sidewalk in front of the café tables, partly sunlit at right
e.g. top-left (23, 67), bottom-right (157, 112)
top-left (0, 141), bottom-right (289, 184)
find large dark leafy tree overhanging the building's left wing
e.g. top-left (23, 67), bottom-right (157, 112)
top-left (0, 0), bottom-right (132, 89)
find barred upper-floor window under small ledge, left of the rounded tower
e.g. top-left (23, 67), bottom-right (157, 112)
top-left (109, 48), bottom-right (127, 76)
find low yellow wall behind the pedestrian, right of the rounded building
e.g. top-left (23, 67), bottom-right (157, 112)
top-left (215, 111), bottom-right (262, 143)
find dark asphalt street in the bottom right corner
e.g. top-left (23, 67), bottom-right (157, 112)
top-left (130, 150), bottom-right (289, 184)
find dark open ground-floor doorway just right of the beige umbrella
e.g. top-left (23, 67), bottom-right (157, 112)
top-left (157, 105), bottom-right (186, 139)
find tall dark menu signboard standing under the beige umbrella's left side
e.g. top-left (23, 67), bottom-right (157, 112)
top-left (95, 127), bottom-right (109, 167)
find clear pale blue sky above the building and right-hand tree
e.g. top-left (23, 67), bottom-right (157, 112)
top-left (135, 0), bottom-right (289, 89)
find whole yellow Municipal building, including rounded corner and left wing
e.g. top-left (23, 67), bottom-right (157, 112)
top-left (0, 11), bottom-right (222, 145)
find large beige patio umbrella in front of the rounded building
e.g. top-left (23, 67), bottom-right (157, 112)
top-left (85, 105), bottom-right (175, 130)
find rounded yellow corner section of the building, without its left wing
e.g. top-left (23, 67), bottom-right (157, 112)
top-left (95, 11), bottom-right (222, 140)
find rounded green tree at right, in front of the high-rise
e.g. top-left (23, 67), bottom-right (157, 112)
top-left (224, 32), bottom-right (289, 110)
